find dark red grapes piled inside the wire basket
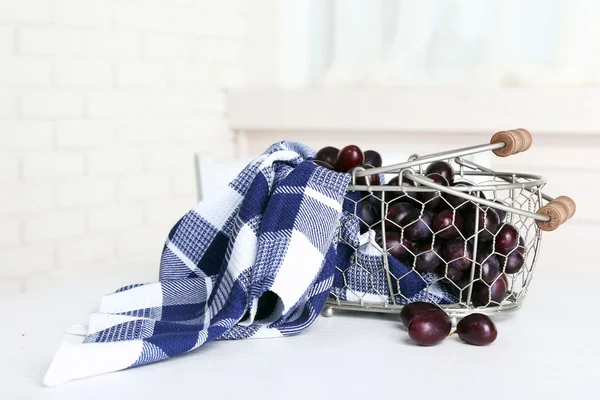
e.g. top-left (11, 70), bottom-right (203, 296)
top-left (315, 145), bottom-right (525, 307)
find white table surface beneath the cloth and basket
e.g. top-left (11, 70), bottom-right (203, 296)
top-left (0, 265), bottom-right (600, 400)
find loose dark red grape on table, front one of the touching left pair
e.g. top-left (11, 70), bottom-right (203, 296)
top-left (408, 310), bottom-right (452, 346)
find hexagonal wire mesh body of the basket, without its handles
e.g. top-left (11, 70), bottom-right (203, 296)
top-left (328, 160), bottom-right (544, 315)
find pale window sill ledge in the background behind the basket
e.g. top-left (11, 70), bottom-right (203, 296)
top-left (227, 87), bottom-right (600, 135)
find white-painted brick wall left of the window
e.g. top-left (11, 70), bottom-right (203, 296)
top-left (0, 0), bottom-right (248, 298)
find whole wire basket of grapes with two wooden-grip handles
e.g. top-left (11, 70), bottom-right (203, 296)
top-left (323, 129), bottom-right (575, 318)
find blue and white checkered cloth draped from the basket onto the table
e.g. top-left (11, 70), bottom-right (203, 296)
top-left (44, 142), bottom-right (454, 386)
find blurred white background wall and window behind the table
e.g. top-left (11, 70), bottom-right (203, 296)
top-left (0, 0), bottom-right (600, 298)
